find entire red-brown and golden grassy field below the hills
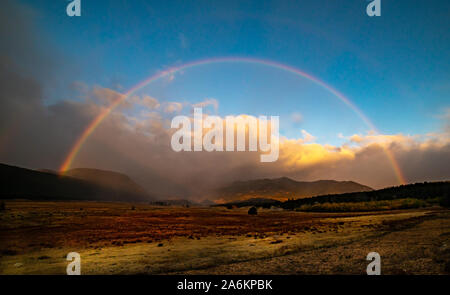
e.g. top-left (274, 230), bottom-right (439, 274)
top-left (0, 201), bottom-right (450, 274)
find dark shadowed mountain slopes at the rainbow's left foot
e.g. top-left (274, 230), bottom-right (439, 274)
top-left (0, 164), bottom-right (152, 202)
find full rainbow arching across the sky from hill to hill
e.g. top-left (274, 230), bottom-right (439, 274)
top-left (59, 57), bottom-right (406, 184)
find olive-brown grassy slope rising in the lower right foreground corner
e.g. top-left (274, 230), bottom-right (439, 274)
top-left (182, 213), bottom-right (450, 275)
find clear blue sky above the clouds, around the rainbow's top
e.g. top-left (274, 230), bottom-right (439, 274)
top-left (21, 0), bottom-right (450, 143)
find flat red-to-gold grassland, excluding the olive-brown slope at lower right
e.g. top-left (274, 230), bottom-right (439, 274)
top-left (0, 201), bottom-right (448, 274)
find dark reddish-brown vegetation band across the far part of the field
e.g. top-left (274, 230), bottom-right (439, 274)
top-left (0, 202), bottom-right (404, 253)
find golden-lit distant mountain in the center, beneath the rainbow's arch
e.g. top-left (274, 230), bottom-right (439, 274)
top-left (215, 177), bottom-right (372, 202)
